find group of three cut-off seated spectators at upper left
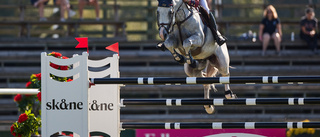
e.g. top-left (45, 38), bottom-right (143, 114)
top-left (30, 0), bottom-right (100, 22)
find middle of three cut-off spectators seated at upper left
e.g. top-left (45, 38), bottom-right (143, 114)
top-left (53, 0), bottom-right (76, 22)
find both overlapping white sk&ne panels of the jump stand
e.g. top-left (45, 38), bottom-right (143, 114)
top-left (41, 53), bottom-right (120, 137)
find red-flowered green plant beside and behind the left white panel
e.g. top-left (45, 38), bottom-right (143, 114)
top-left (10, 52), bottom-right (72, 137)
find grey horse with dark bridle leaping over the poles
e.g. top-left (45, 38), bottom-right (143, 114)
top-left (157, 0), bottom-right (236, 114)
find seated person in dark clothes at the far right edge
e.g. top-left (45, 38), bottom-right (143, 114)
top-left (300, 8), bottom-right (318, 53)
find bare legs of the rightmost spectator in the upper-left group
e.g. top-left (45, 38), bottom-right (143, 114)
top-left (79, 0), bottom-right (100, 21)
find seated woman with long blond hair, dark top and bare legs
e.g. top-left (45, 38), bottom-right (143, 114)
top-left (259, 5), bottom-right (282, 56)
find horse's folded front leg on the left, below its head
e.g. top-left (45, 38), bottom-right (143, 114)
top-left (164, 35), bottom-right (185, 64)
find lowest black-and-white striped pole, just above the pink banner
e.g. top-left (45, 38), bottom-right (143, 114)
top-left (121, 122), bottom-right (320, 129)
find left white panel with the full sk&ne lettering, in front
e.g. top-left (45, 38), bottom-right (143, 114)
top-left (41, 53), bottom-right (89, 137)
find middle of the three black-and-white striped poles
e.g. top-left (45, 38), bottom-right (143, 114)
top-left (120, 98), bottom-right (320, 106)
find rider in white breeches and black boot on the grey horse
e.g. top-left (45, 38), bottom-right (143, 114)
top-left (183, 0), bottom-right (227, 46)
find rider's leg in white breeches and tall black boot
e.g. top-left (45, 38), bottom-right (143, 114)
top-left (200, 0), bottom-right (227, 46)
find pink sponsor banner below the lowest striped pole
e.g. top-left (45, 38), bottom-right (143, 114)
top-left (136, 129), bottom-right (286, 137)
